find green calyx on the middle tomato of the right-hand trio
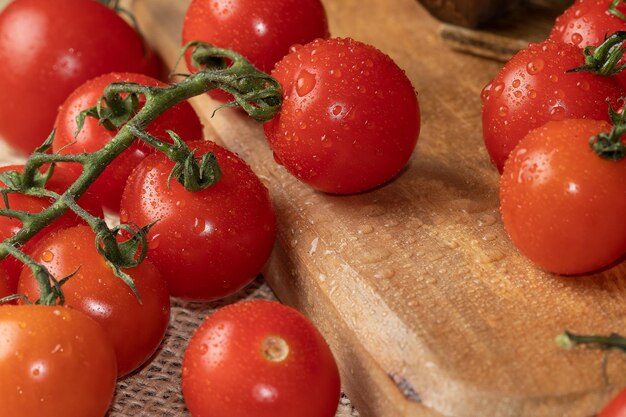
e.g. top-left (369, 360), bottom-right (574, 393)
top-left (567, 31), bottom-right (626, 76)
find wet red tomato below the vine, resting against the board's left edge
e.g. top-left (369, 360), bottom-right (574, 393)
top-left (120, 141), bottom-right (276, 300)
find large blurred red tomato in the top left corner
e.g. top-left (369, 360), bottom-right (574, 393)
top-left (0, 0), bottom-right (155, 153)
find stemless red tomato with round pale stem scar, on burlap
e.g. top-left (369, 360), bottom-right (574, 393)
top-left (182, 300), bottom-right (339, 417)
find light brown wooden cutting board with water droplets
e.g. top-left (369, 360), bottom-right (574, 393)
top-left (136, 0), bottom-right (626, 417)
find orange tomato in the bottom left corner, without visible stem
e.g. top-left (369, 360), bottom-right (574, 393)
top-left (0, 305), bottom-right (116, 417)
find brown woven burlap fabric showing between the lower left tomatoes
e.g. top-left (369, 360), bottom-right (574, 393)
top-left (107, 279), bottom-right (359, 417)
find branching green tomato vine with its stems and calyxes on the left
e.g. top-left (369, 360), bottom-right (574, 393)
top-left (0, 42), bottom-right (281, 305)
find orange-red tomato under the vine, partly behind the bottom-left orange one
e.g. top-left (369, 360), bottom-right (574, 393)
top-left (18, 226), bottom-right (170, 377)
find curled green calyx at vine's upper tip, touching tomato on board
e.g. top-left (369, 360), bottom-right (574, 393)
top-left (179, 41), bottom-right (282, 122)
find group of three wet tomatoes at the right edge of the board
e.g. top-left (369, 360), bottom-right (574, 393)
top-left (482, 0), bottom-right (626, 275)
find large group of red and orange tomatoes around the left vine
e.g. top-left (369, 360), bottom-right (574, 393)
top-left (0, 0), bottom-right (420, 417)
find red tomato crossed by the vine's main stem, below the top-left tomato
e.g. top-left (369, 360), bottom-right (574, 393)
top-left (53, 73), bottom-right (202, 211)
